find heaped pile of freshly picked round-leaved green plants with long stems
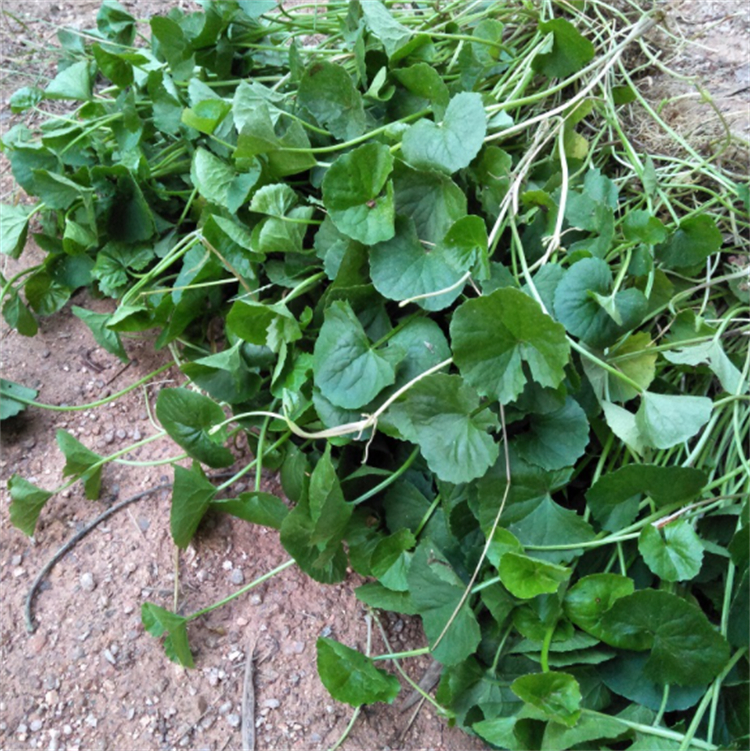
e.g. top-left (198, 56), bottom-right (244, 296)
top-left (2, 0), bottom-right (750, 749)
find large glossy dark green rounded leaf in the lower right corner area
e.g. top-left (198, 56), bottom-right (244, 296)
top-left (598, 589), bottom-right (729, 686)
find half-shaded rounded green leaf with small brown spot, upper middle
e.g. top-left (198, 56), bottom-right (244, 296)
top-left (322, 143), bottom-right (395, 245)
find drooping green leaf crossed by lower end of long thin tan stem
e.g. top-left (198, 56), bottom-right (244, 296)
top-left (408, 540), bottom-right (481, 665)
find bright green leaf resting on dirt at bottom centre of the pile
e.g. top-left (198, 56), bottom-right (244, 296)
top-left (315, 637), bottom-right (401, 707)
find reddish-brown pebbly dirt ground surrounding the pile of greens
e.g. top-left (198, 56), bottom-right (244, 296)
top-left (0, 0), bottom-right (750, 751)
